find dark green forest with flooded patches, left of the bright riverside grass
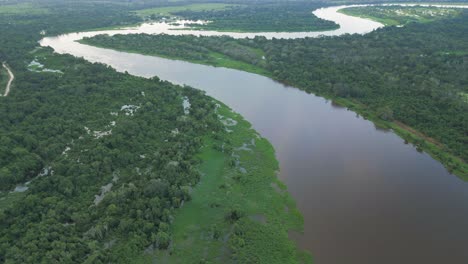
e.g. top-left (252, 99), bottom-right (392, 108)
top-left (0, 49), bottom-right (225, 263)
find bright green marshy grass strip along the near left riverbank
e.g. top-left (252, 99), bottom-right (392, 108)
top-left (137, 102), bottom-right (311, 264)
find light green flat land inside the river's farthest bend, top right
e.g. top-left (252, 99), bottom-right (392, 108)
top-left (338, 6), bottom-right (461, 26)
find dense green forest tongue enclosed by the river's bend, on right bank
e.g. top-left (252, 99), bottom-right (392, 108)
top-left (86, 11), bottom-right (468, 176)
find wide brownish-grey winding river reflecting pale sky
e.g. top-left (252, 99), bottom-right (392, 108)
top-left (41, 6), bottom-right (468, 264)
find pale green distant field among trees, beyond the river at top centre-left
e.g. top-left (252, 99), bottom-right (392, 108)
top-left (136, 3), bottom-right (239, 17)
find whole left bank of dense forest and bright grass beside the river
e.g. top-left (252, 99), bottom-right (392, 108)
top-left (0, 1), bottom-right (307, 263)
